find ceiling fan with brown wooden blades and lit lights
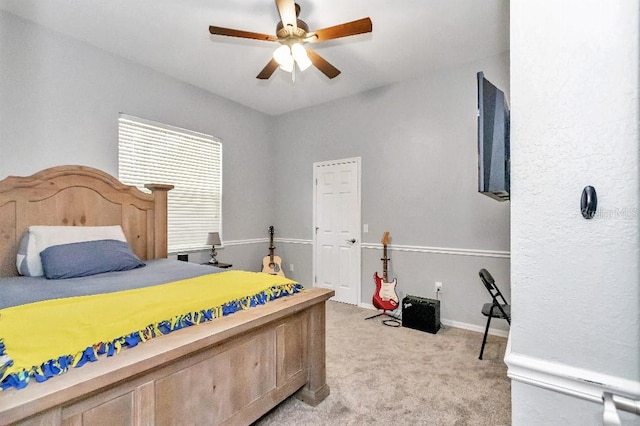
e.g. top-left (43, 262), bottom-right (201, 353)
top-left (209, 0), bottom-right (373, 80)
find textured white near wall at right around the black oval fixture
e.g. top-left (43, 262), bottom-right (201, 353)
top-left (511, 0), bottom-right (640, 424)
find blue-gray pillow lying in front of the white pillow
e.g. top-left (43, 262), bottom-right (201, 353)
top-left (40, 240), bottom-right (145, 279)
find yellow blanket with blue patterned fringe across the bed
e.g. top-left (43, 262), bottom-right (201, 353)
top-left (0, 271), bottom-right (301, 389)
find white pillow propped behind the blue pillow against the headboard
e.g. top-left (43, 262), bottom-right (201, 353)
top-left (16, 225), bottom-right (127, 277)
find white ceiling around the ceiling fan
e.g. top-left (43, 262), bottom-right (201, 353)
top-left (0, 0), bottom-right (509, 115)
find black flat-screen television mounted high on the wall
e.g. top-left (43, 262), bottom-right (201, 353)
top-left (478, 71), bottom-right (511, 201)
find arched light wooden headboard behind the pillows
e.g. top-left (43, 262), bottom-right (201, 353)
top-left (0, 166), bottom-right (173, 277)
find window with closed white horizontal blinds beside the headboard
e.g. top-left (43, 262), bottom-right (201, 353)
top-left (118, 114), bottom-right (222, 253)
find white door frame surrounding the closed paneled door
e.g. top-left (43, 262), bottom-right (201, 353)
top-left (311, 157), bottom-right (362, 306)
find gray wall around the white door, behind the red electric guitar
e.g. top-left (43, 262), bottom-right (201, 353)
top-left (274, 53), bottom-right (510, 330)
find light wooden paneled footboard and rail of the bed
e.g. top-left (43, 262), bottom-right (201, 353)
top-left (0, 288), bottom-right (333, 426)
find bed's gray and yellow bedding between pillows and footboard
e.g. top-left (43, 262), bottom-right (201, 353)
top-left (0, 259), bottom-right (302, 389)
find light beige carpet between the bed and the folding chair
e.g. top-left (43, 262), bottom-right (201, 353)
top-left (255, 302), bottom-right (511, 426)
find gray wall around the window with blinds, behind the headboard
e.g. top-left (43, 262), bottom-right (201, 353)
top-left (0, 12), bottom-right (274, 269)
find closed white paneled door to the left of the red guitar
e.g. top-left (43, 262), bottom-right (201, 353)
top-left (313, 158), bottom-right (361, 305)
